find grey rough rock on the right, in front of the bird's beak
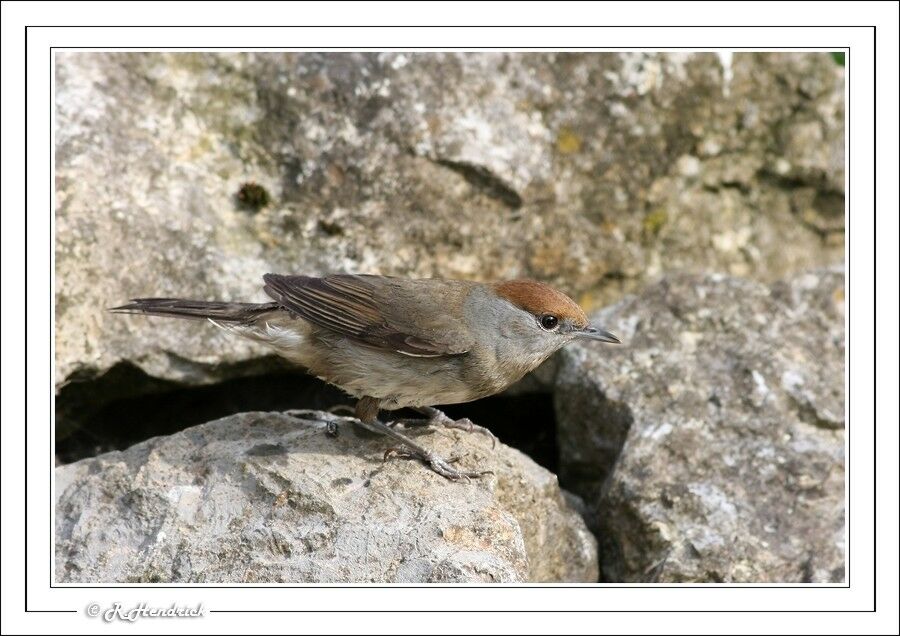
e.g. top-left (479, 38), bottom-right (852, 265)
top-left (555, 269), bottom-right (845, 582)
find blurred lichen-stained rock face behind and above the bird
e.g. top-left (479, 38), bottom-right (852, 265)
top-left (55, 53), bottom-right (844, 387)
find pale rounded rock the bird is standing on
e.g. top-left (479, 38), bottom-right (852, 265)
top-left (56, 413), bottom-right (597, 583)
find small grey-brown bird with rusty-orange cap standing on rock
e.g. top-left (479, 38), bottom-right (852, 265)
top-left (110, 274), bottom-right (619, 480)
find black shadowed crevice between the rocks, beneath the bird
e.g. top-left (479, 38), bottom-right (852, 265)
top-left (56, 362), bottom-right (558, 473)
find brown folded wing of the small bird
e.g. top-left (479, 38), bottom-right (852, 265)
top-left (263, 274), bottom-right (472, 357)
